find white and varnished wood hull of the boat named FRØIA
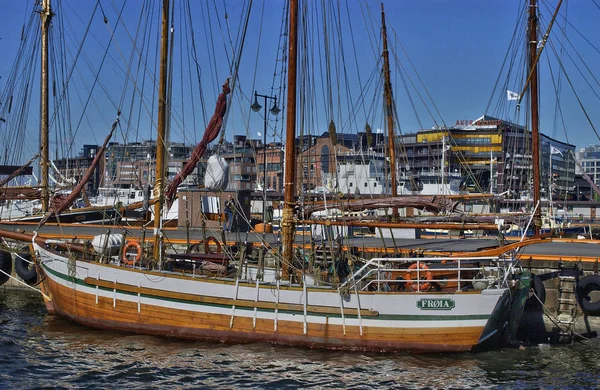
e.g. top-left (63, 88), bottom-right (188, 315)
top-left (36, 246), bottom-right (507, 352)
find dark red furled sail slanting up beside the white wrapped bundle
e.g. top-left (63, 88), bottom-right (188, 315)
top-left (165, 79), bottom-right (231, 205)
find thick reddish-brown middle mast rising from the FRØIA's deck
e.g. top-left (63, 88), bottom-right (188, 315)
top-left (281, 0), bottom-right (298, 280)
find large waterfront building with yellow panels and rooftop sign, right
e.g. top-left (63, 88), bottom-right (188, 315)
top-left (397, 115), bottom-right (575, 199)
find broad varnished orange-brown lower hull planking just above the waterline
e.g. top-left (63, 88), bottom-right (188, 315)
top-left (49, 281), bottom-right (482, 350)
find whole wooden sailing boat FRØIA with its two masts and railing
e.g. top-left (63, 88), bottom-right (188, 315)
top-left (0, 0), bottom-right (536, 352)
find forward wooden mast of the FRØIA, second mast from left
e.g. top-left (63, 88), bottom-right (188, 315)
top-left (153, 0), bottom-right (169, 262)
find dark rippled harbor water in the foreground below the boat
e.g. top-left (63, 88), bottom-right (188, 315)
top-left (0, 288), bottom-right (600, 389)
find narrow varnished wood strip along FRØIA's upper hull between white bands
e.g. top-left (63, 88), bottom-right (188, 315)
top-left (84, 277), bottom-right (379, 317)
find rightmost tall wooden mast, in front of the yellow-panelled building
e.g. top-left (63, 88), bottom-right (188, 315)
top-left (528, 0), bottom-right (542, 236)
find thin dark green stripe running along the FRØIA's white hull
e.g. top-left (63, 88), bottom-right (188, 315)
top-left (42, 264), bottom-right (490, 321)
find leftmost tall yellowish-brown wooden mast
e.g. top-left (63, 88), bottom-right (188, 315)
top-left (40, 0), bottom-right (53, 213)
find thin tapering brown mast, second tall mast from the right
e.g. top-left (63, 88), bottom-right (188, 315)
top-left (381, 3), bottom-right (398, 220)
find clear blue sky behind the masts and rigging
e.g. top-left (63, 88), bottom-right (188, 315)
top-left (0, 0), bottom-right (600, 164)
